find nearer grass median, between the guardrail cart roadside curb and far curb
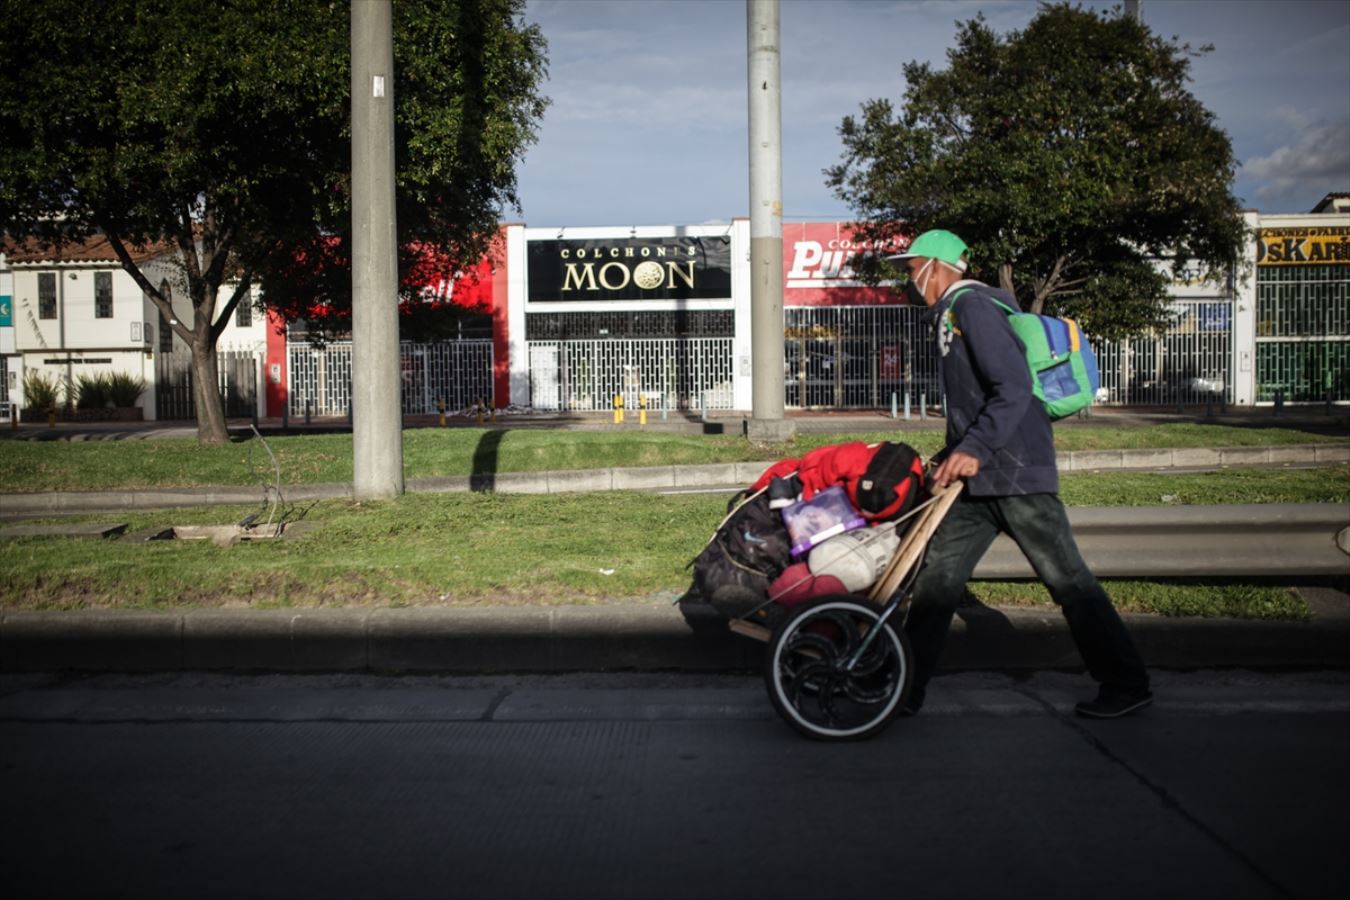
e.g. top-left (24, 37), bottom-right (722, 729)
top-left (0, 466), bottom-right (1350, 618)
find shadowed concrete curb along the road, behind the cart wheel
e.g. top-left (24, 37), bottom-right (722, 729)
top-left (0, 604), bottom-right (1350, 673)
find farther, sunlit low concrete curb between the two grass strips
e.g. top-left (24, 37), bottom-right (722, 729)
top-left (0, 444), bottom-right (1350, 515)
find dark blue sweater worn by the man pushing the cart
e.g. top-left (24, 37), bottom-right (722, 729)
top-left (929, 281), bottom-right (1060, 497)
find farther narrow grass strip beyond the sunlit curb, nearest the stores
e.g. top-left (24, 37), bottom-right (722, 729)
top-left (0, 424), bottom-right (1345, 493)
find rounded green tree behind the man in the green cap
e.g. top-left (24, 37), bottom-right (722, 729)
top-left (825, 4), bottom-right (1243, 337)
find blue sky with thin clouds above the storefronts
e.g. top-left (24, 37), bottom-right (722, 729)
top-left (504, 0), bottom-right (1350, 227)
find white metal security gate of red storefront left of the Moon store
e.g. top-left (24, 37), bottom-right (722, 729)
top-left (288, 340), bottom-right (493, 417)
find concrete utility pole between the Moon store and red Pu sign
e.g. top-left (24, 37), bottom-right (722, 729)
top-left (745, 0), bottom-right (797, 443)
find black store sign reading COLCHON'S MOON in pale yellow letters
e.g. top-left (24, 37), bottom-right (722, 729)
top-left (527, 237), bottom-right (732, 302)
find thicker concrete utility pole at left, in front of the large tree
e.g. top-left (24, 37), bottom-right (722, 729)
top-left (351, 0), bottom-right (404, 499)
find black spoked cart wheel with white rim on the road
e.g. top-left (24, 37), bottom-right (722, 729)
top-left (764, 594), bottom-right (913, 741)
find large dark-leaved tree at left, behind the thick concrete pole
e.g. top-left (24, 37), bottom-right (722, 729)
top-left (0, 0), bottom-right (547, 443)
